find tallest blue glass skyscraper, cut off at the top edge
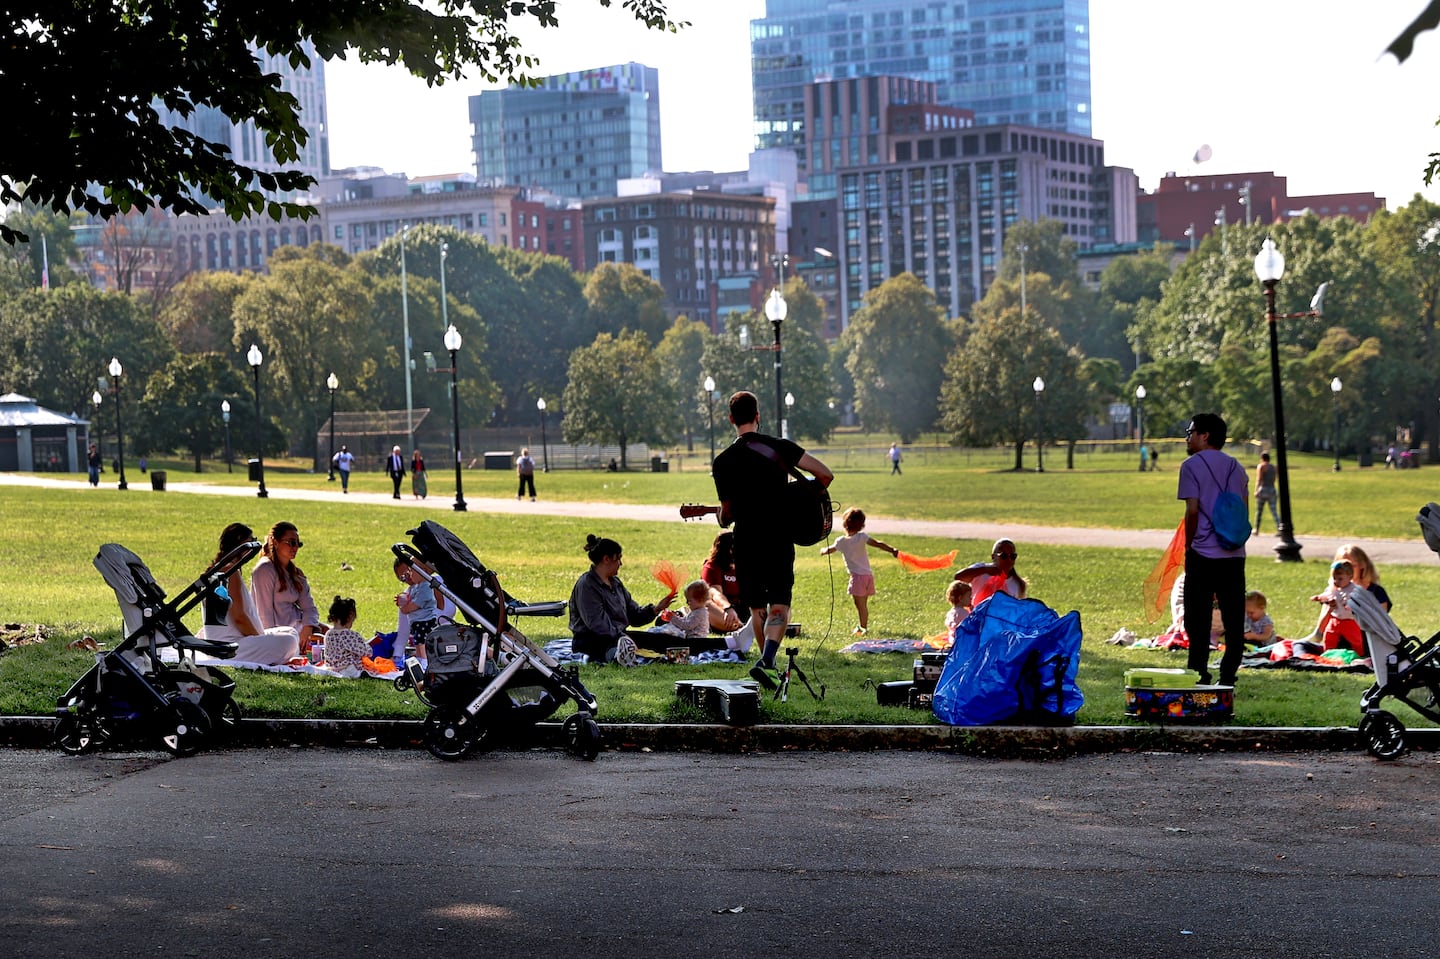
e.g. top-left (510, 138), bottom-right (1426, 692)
top-left (750, 0), bottom-right (1090, 173)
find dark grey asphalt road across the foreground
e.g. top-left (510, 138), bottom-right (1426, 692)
top-left (0, 749), bottom-right (1440, 959)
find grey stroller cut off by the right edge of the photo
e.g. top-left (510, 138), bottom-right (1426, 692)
top-left (1349, 503), bottom-right (1440, 759)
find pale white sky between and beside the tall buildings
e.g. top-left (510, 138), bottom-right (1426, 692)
top-left (325, 0), bottom-right (1440, 209)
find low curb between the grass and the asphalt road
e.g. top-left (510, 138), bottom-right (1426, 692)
top-left (8, 716), bottom-right (1440, 757)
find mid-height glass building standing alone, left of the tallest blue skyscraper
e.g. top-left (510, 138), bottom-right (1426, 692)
top-left (469, 63), bottom-right (661, 197)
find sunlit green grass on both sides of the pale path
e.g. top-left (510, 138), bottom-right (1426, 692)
top-left (0, 445), bottom-right (1440, 726)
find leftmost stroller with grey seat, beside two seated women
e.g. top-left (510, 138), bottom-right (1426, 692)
top-left (55, 543), bottom-right (261, 756)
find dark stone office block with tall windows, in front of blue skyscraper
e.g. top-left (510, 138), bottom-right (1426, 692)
top-left (791, 113), bottom-right (1136, 325)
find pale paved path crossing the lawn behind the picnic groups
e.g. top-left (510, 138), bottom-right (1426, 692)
top-left (11, 472), bottom-right (1437, 566)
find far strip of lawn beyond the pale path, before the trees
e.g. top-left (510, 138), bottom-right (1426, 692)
top-left (106, 444), bottom-right (1436, 543)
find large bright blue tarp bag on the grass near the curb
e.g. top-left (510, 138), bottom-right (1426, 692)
top-left (932, 593), bottom-right (1084, 726)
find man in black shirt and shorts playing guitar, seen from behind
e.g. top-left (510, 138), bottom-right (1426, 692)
top-left (711, 390), bottom-right (835, 690)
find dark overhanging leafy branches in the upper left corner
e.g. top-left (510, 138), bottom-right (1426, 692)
top-left (0, 0), bottom-right (685, 243)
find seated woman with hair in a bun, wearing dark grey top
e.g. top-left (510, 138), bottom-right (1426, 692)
top-left (570, 534), bottom-right (675, 665)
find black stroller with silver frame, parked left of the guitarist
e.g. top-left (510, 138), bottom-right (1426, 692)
top-left (390, 520), bottom-right (600, 760)
